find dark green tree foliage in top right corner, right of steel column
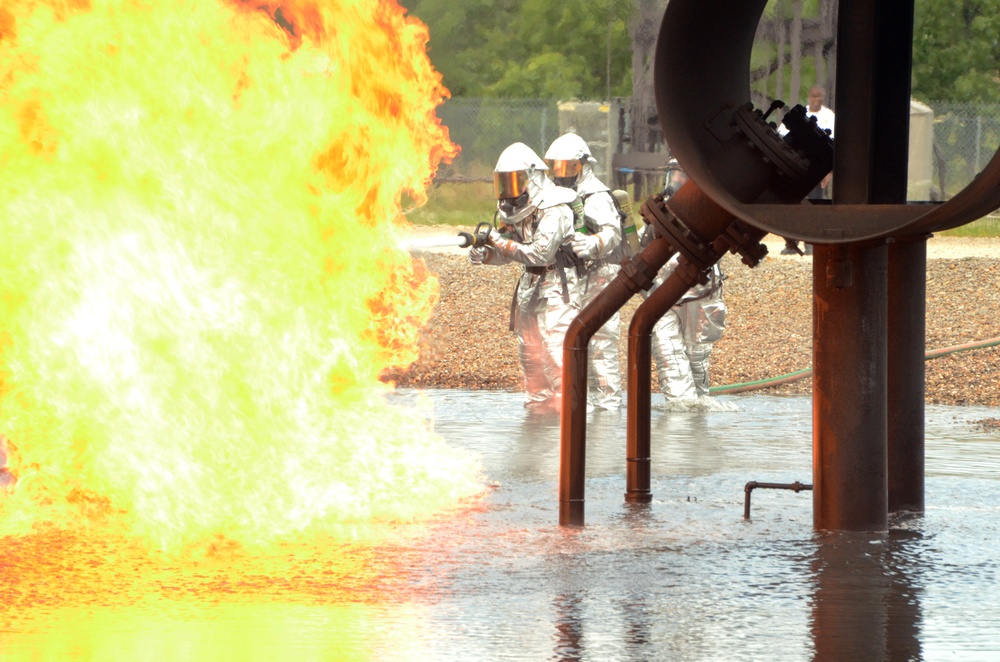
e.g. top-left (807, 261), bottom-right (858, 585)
top-left (913, 0), bottom-right (1000, 103)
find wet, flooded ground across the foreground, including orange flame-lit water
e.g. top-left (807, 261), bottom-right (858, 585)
top-left (0, 390), bottom-right (1000, 660)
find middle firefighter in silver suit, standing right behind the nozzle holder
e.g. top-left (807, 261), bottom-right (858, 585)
top-left (545, 133), bottom-right (623, 410)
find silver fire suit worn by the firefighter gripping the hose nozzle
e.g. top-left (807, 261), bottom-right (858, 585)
top-left (482, 180), bottom-right (580, 411)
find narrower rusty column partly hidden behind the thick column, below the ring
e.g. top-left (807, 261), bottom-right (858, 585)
top-left (887, 237), bottom-right (927, 512)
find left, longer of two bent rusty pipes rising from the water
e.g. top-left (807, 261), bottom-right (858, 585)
top-left (559, 231), bottom-right (676, 526)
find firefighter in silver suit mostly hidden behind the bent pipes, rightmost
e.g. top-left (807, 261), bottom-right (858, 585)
top-left (643, 160), bottom-right (726, 402)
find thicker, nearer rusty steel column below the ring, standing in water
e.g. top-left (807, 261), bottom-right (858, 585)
top-left (813, 241), bottom-right (888, 531)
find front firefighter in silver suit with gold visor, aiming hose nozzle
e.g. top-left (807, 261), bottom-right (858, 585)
top-left (469, 143), bottom-right (579, 411)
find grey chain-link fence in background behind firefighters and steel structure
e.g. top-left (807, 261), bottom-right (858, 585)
top-left (438, 98), bottom-right (1000, 215)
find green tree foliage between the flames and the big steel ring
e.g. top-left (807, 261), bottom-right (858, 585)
top-left (408, 0), bottom-right (631, 99)
